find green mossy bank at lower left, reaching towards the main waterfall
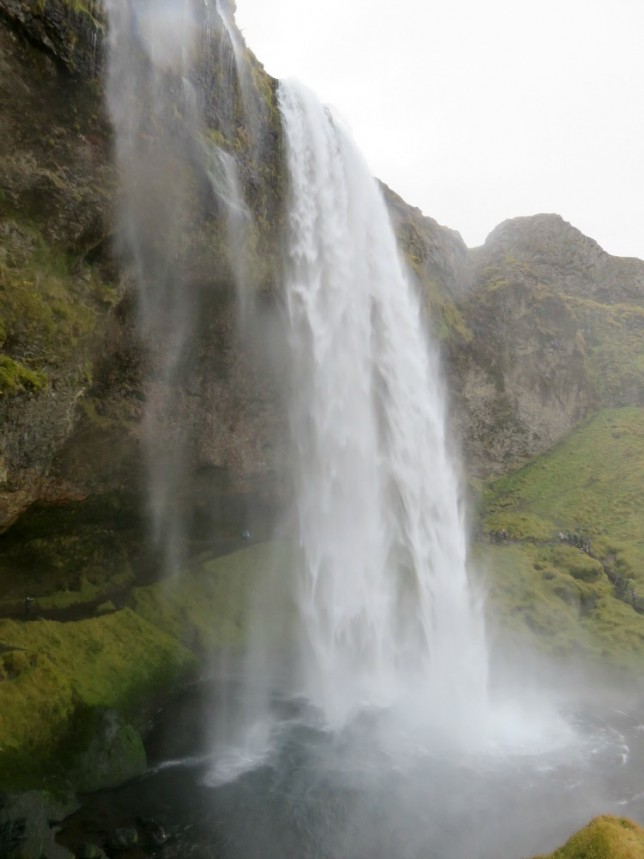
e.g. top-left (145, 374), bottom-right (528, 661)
top-left (0, 543), bottom-right (294, 789)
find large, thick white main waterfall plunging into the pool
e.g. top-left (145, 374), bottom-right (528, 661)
top-left (270, 83), bottom-right (487, 732)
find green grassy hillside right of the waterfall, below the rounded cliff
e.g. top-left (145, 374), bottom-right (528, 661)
top-left (476, 408), bottom-right (644, 667)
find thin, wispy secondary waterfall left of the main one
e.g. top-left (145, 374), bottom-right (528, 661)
top-left (106, 0), bottom-right (250, 572)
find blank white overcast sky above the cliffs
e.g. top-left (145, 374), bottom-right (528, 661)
top-left (237, 0), bottom-right (644, 259)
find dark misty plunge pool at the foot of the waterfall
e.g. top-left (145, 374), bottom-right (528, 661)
top-left (60, 684), bottom-right (644, 859)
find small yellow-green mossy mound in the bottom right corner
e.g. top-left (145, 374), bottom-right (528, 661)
top-left (535, 815), bottom-right (644, 859)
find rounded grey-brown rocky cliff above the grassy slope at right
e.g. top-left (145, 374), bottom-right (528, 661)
top-left (448, 215), bottom-right (644, 474)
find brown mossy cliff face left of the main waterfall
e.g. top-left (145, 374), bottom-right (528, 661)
top-left (0, 0), bottom-right (283, 531)
